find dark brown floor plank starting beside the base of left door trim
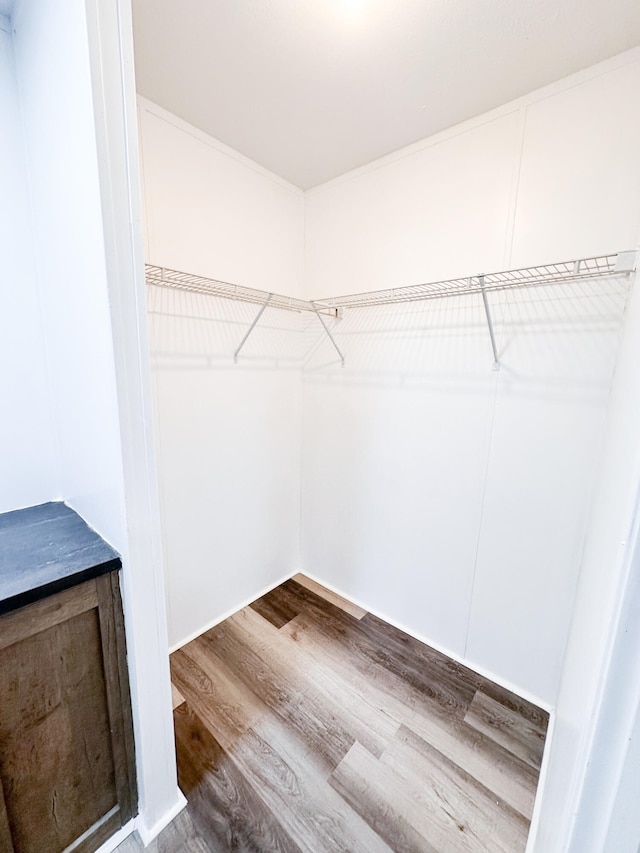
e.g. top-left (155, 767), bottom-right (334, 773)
top-left (174, 703), bottom-right (300, 853)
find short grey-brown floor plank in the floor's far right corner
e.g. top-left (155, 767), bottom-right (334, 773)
top-left (464, 690), bottom-right (544, 770)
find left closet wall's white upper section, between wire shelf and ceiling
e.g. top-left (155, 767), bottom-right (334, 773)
top-left (139, 98), bottom-right (304, 296)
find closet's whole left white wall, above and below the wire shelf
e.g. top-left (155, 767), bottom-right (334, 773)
top-left (139, 100), bottom-right (304, 647)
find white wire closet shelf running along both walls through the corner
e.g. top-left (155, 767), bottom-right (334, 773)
top-left (145, 250), bottom-right (638, 317)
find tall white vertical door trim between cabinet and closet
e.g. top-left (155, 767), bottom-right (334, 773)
top-left (86, 0), bottom-right (185, 841)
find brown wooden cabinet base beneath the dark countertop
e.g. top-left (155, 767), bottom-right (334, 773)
top-left (0, 571), bottom-right (137, 853)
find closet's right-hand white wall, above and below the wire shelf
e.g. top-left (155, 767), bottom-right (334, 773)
top-left (302, 51), bottom-right (640, 703)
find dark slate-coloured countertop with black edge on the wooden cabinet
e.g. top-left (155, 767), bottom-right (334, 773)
top-left (0, 503), bottom-right (121, 614)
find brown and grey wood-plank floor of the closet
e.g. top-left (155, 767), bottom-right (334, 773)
top-left (118, 576), bottom-right (548, 853)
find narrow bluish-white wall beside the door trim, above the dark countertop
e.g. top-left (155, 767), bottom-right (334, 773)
top-left (13, 0), bottom-right (126, 547)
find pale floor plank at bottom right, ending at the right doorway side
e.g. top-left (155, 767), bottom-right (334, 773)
top-left (380, 726), bottom-right (529, 853)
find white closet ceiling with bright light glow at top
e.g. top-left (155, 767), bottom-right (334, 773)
top-left (132, 0), bottom-right (640, 189)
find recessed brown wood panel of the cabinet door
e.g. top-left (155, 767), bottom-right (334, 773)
top-left (0, 608), bottom-right (117, 853)
